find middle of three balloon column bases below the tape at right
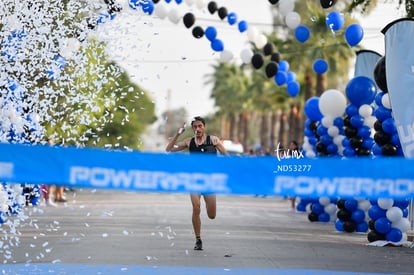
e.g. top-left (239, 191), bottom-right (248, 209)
top-left (335, 199), bottom-right (371, 233)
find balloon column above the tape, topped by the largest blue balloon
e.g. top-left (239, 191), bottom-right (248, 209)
top-left (342, 76), bottom-right (377, 157)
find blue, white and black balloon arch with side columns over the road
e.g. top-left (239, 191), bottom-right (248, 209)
top-left (0, 0), bottom-right (409, 246)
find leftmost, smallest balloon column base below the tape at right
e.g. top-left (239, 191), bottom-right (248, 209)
top-left (308, 197), bottom-right (336, 222)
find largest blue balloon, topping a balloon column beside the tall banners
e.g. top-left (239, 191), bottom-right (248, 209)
top-left (345, 76), bottom-right (377, 107)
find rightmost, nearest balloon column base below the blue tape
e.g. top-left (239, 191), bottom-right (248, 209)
top-left (368, 199), bottom-right (410, 242)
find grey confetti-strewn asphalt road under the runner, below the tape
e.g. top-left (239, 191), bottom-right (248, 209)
top-left (0, 189), bottom-right (414, 275)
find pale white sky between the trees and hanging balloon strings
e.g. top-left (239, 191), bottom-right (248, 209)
top-left (97, 0), bottom-right (402, 123)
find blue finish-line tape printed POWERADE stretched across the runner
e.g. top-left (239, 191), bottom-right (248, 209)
top-left (0, 144), bottom-right (414, 199)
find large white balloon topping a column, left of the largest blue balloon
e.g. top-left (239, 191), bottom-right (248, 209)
top-left (319, 89), bottom-right (346, 117)
